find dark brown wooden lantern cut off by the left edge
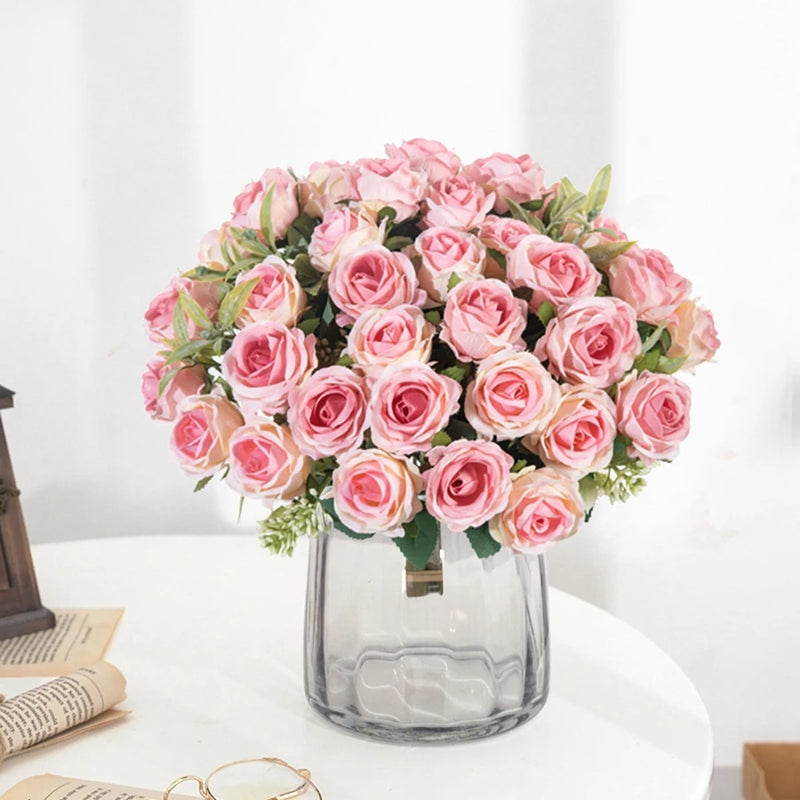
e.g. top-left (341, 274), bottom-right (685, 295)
top-left (0, 386), bottom-right (55, 639)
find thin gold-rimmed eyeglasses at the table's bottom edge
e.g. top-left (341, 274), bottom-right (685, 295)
top-left (163, 758), bottom-right (322, 800)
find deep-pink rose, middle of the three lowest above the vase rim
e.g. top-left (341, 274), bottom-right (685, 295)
top-left (423, 439), bottom-right (514, 531)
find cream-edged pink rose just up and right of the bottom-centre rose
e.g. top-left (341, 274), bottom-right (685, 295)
top-left (464, 350), bottom-right (561, 441)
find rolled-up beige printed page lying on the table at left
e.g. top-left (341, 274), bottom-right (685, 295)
top-left (0, 661), bottom-right (125, 761)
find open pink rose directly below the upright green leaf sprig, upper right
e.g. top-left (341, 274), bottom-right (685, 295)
top-left (508, 233), bottom-right (602, 311)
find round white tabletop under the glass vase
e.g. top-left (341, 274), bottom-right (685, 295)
top-left (0, 535), bottom-right (713, 800)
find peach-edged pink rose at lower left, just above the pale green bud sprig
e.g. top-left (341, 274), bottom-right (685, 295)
top-left (226, 420), bottom-right (311, 505)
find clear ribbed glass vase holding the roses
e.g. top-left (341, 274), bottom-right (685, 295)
top-left (305, 528), bottom-right (549, 742)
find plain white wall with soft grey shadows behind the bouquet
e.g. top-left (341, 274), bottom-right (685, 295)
top-left (0, 0), bottom-right (800, 780)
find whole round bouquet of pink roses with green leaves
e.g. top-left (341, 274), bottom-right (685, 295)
top-left (143, 139), bottom-right (719, 566)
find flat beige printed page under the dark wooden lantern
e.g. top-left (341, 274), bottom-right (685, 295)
top-left (0, 608), bottom-right (124, 678)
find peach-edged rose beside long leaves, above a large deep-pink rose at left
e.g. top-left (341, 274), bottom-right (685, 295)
top-left (236, 256), bottom-right (306, 328)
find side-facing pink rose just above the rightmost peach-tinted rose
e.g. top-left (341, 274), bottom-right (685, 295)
top-left (608, 247), bottom-right (692, 325)
